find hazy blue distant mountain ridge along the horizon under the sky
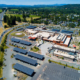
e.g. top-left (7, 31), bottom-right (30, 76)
top-left (0, 4), bottom-right (67, 7)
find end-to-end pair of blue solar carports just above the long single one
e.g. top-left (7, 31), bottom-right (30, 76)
top-left (13, 47), bottom-right (44, 60)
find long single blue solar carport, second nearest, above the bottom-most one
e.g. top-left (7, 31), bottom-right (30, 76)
top-left (15, 54), bottom-right (37, 66)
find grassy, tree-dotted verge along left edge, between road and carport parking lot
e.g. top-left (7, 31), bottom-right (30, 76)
top-left (0, 30), bottom-right (13, 78)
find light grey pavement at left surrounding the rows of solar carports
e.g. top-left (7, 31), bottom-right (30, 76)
top-left (3, 29), bottom-right (43, 80)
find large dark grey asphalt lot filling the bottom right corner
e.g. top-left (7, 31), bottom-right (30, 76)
top-left (31, 63), bottom-right (80, 80)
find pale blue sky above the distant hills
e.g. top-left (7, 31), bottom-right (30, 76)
top-left (0, 0), bottom-right (80, 5)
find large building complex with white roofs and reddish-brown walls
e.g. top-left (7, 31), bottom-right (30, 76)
top-left (25, 29), bottom-right (72, 47)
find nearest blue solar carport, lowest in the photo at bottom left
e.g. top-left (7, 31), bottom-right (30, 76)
top-left (13, 63), bottom-right (34, 76)
